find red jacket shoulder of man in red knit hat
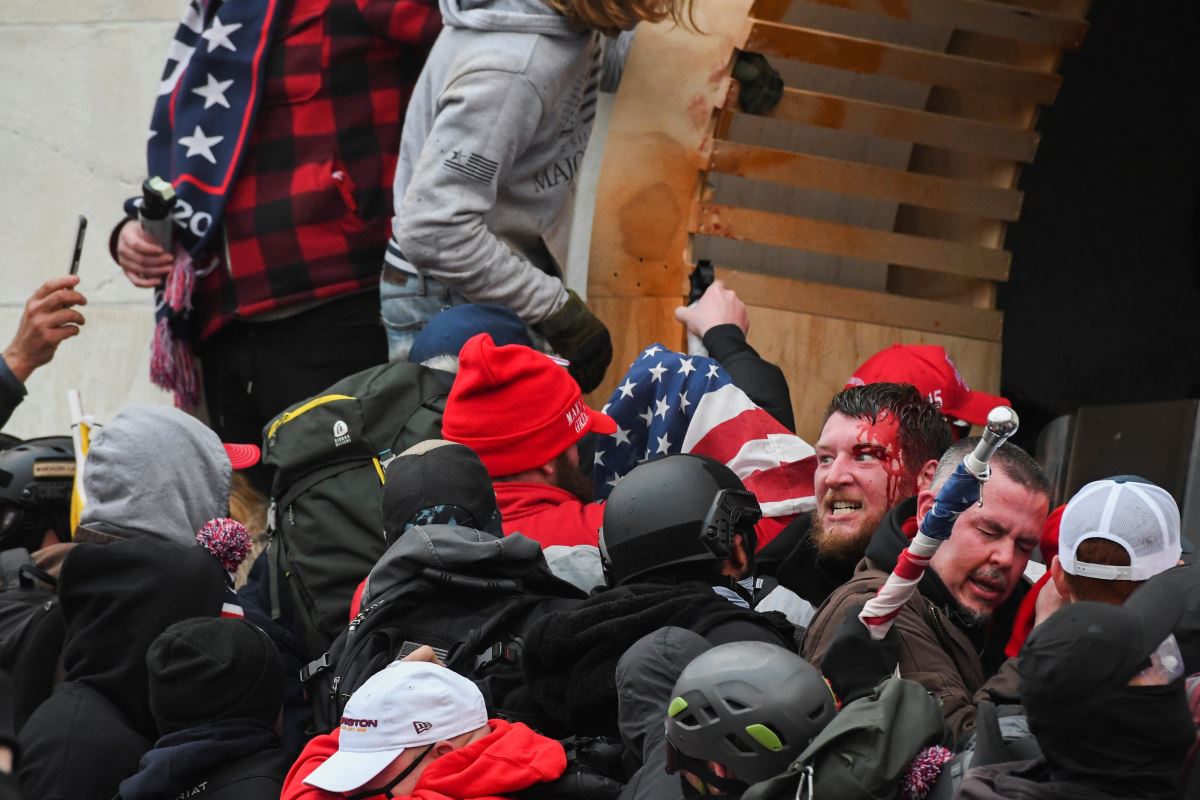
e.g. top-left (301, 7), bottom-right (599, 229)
top-left (496, 481), bottom-right (604, 547)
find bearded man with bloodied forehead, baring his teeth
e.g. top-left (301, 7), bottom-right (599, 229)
top-left (776, 384), bottom-right (950, 607)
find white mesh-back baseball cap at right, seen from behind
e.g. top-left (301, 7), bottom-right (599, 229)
top-left (1058, 476), bottom-right (1183, 581)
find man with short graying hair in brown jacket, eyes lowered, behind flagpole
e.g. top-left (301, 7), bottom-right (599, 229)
top-left (802, 439), bottom-right (1050, 744)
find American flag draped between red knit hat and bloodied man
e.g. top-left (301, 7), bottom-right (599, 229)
top-left (593, 344), bottom-right (816, 548)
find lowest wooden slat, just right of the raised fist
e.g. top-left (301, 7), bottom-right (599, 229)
top-left (716, 267), bottom-right (1003, 342)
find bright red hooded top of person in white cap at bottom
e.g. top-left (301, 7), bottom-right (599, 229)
top-left (280, 720), bottom-right (566, 800)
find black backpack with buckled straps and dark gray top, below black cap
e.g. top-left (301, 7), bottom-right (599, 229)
top-left (300, 525), bottom-right (584, 730)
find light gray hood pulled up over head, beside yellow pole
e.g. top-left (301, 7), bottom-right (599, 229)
top-left (79, 405), bottom-right (233, 545)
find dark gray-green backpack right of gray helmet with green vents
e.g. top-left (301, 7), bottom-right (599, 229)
top-left (742, 678), bottom-right (946, 800)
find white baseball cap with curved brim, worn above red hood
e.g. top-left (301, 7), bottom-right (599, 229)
top-left (304, 661), bottom-right (487, 792)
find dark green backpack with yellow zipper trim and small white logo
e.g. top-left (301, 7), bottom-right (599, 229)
top-left (263, 362), bottom-right (451, 658)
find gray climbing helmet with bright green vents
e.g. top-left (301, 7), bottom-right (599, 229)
top-left (667, 642), bottom-right (836, 792)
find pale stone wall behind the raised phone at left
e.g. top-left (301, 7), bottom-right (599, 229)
top-left (0, 0), bottom-right (182, 437)
